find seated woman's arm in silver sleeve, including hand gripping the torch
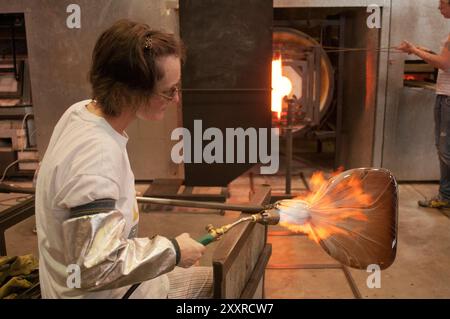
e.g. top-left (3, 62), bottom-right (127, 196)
top-left (60, 176), bottom-right (204, 291)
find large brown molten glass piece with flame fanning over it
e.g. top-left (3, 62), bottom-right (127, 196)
top-left (276, 168), bottom-right (398, 269)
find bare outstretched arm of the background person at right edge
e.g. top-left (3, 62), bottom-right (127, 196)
top-left (397, 35), bottom-right (450, 71)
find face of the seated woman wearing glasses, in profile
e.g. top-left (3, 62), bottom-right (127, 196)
top-left (136, 55), bottom-right (181, 121)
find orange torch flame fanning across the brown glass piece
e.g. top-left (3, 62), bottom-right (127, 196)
top-left (280, 168), bottom-right (373, 243)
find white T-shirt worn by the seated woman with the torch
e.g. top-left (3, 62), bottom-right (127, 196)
top-left (36, 100), bottom-right (169, 298)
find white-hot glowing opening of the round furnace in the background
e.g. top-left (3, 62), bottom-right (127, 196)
top-left (272, 56), bottom-right (292, 118)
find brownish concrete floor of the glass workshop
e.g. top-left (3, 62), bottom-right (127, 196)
top-left (0, 175), bottom-right (450, 298)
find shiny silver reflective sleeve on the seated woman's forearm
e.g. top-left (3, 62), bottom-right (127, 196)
top-left (63, 210), bottom-right (176, 291)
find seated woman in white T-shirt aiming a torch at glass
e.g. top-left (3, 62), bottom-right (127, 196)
top-left (36, 20), bottom-right (212, 298)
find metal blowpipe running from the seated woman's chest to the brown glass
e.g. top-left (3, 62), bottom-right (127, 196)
top-left (136, 197), bottom-right (266, 213)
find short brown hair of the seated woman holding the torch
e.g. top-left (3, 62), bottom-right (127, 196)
top-left (89, 19), bottom-right (185, 117)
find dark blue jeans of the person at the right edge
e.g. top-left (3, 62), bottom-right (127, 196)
top-left (434, 95), bottom-right (450, 201)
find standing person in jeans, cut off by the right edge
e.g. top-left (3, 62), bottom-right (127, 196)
top-left (397, 0), bottom-right (450, 208)
